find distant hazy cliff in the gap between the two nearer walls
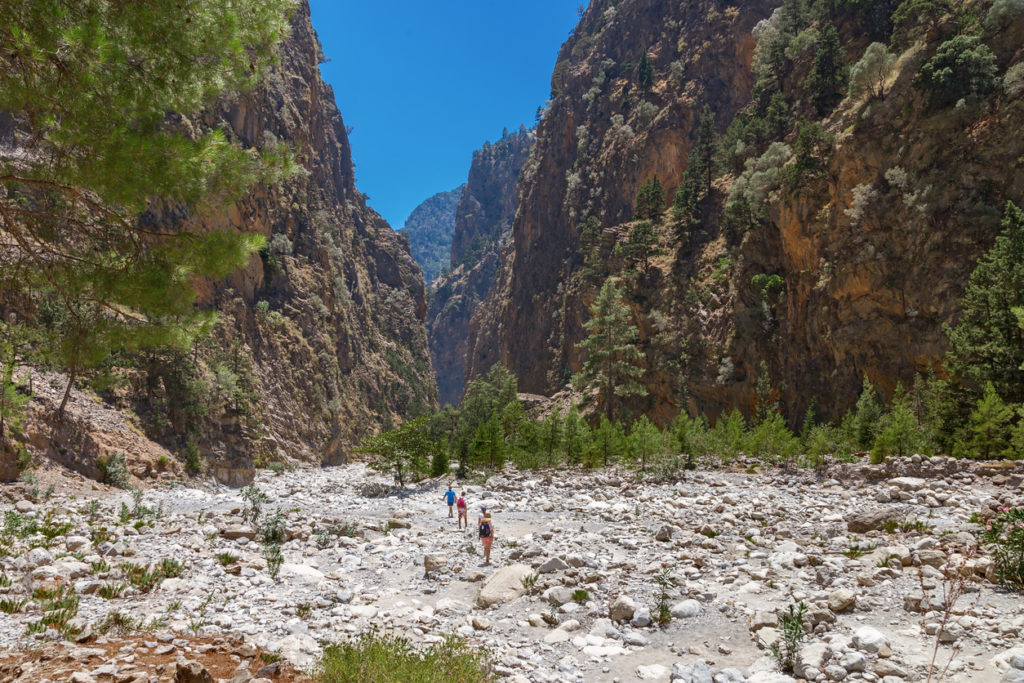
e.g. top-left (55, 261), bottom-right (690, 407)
top-left (427, 128), bottom-right (535, 404)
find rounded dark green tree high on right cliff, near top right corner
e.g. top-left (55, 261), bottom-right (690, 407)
top-left (913, 34), bottom-right (999, 108)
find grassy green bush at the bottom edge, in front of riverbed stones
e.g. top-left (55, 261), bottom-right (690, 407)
top-left (313, 632), bottom-right (496, 683)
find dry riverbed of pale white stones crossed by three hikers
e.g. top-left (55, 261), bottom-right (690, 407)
top-left (0, 458), bottom-right (1024, 683)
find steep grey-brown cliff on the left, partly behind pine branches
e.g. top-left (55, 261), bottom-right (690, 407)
top-left (138, 2), bottom-right (436, 481)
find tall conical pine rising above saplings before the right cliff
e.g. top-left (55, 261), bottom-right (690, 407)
top-left (573, 278), bottom-right (647, 421)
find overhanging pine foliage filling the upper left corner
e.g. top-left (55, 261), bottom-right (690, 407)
top-left (0, 0), bottom-right (297, 417)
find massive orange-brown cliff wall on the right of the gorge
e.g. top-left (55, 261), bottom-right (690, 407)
top-left (467, 0), bottom-right (1024, 422)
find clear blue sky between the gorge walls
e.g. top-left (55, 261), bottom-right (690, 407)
top-left (310, 0), bottom-right (586, 229)
